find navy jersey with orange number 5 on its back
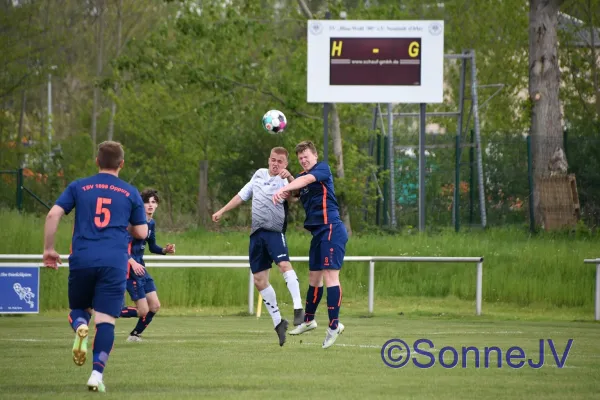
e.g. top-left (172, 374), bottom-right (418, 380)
top-left (56, 173), bottom-right (146, 270)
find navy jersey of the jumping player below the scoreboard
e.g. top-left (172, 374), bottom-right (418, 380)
top-left (296, 161), bottom-right (342, 230)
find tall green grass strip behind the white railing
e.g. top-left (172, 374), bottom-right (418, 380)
top-left (0, 209), bottom-right (600, 316)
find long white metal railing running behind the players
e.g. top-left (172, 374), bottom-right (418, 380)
top-left (0, 254), bottom-right (486, 315)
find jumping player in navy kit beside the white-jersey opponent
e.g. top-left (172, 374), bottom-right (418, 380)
top-left (273, 141), bottom-right (348, 349)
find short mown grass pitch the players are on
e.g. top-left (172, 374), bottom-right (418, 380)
top-left (0, 300), bottom-right (600, 400)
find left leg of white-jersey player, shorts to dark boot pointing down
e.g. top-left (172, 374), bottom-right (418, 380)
top-left (249, 232), bottom-right (288, 346)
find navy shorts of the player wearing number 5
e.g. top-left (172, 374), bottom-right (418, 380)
top-left (68, 267), bottom-right (127, 318)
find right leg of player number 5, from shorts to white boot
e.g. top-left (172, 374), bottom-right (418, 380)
top-left (87, 267), bottom-right (127, 392)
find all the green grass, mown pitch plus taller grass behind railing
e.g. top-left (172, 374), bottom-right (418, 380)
top-left (0, 210), bottom-right (600, 400)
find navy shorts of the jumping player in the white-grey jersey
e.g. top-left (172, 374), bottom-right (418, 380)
top-left (249, 230), bottom-right (290, 274)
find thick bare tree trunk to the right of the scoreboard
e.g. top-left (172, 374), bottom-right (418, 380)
top-left (529, 0), bottom-right (564, 225)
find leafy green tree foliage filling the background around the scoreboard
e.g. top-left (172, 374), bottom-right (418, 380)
top-left (0, 0), bottom-right (598, 230)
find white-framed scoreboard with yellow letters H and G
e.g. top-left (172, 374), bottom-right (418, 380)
top-left (307, 20), bottom-right (444, 103)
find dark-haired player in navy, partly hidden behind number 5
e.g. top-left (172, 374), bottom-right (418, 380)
top-left (121, 189), bottom-right (175, 342)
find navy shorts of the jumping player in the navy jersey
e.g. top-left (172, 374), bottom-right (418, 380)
top-left (308, 222), bottom-right (348, 271)
